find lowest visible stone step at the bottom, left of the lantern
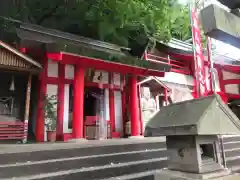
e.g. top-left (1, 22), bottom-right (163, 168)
top-left (15, 159), bottom-right (166, 180)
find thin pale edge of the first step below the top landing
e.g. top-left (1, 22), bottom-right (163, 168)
top-left (0, 149), bottom-right (166, 168)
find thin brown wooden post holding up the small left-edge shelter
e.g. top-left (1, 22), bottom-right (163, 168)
top-left (23, 74), bottom-right (32, 142)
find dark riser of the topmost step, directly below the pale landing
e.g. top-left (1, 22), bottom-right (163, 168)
top-left (0, 142), bottom-right (166, 166)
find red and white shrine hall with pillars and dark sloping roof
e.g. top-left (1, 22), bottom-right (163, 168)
top-left (17, 24), bottom-right (170, 142)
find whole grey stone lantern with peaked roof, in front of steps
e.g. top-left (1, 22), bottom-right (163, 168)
top-left (145, 95), bottom-right (240, 180)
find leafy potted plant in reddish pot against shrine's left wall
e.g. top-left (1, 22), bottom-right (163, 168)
top-left (44, 95), bottom-right (57, 142)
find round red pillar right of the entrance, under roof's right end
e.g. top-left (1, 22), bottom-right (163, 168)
top-left (129, 75), bottom-right (140, 136)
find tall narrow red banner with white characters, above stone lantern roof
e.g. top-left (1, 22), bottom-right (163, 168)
top-left (191, 8), bottom-right (207, 97)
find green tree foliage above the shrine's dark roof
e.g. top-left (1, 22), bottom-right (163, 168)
top-left (0, 0), bottom-right (190, 47)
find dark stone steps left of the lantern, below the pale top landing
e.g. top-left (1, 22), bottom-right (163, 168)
top-left (0, 139), bottom-right (167, 180)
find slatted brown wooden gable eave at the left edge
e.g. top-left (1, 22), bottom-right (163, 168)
top-left (0, 41), bottom-right (42, 72)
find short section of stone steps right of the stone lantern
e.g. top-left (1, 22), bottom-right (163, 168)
top-left (223, 136), bottom-right (240, 173)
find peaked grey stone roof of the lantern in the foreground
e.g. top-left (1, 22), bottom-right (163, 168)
top-left (145, 95), bottom-right (240, 136)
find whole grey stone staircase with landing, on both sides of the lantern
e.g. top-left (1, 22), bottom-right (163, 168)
top-left (0, 137), bottom-right (240, 180)
